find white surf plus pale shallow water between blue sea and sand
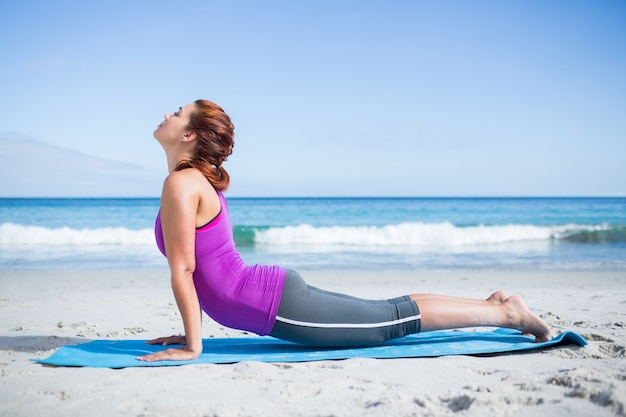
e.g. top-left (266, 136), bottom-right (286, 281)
top-left (0, 223), bottom-right (624, 269)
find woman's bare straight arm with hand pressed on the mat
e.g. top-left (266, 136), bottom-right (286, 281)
top-left (138, 170), bottom-right (202, 362)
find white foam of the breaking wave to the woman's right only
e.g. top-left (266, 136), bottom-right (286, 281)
top-left (255, 223), bottom-right (599, 247)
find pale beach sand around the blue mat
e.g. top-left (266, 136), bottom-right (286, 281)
top-left (0, 270), bottom-right (626, 417)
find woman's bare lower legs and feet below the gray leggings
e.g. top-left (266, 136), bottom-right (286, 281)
top-left (411, 293), bottom-right (552, 342)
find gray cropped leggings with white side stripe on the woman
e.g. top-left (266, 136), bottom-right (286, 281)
top-left (270, 270), bottom-right (420, 347)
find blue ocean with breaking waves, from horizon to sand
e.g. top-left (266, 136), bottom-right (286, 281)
top-left (0, 195), bottom-right (626, 270)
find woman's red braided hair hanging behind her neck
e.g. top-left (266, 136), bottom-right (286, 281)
top-left (176, 100), bottom-right (235, 191)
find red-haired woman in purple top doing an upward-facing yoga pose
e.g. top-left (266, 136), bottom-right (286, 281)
top-left (138, 100), bottom-right (551, 362)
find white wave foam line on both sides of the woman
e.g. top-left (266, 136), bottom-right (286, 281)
top-left (0, 223), bottom-right (603, 247)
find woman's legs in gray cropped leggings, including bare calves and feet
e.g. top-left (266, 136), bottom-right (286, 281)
top-left (271, 271), bottom-right (552, 346)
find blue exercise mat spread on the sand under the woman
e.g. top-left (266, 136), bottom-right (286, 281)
top-left (33, 329), bottom-right (587, 368)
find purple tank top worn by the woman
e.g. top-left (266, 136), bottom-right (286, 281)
top-left (154, 192), bottom-right (285, 335)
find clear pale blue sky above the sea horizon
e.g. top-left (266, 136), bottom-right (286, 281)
top-left (0, 0), bottom-right (626, 197)
